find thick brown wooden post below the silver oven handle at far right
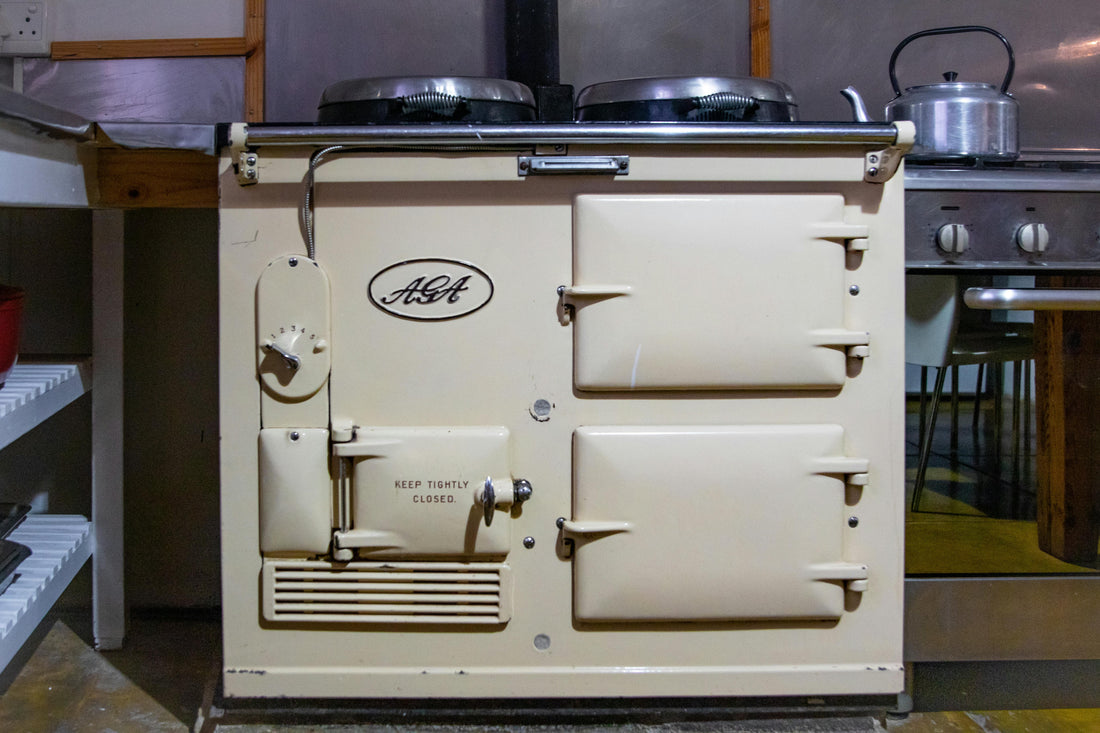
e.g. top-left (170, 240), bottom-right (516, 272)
top-left (1035, 270), bottom-right (1100, 562)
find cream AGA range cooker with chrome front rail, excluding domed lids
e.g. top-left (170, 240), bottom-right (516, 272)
top-left (219, 81), bottom-right (913, 698)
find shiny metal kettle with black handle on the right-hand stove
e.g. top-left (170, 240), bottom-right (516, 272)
top-left (842, 25), bottom-right (1020, 161)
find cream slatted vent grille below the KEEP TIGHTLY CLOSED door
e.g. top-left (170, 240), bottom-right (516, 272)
top-left (263, 560), bottom-right (512, 624)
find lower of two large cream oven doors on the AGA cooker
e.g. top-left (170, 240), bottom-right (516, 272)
top-left (562, 425), bottom-right (870, 622)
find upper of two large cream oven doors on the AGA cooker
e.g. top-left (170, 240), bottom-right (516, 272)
top-left (562, 194), bottom-right (869, 390)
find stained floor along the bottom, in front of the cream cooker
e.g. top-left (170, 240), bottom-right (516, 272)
top-left (0, 614), bottom-right (1100, 733)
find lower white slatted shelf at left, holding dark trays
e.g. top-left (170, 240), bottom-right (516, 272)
top-left (0, 514), bottom-right (91, 669)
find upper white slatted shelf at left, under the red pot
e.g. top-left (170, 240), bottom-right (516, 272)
top-left (0, 362), bottom-right (91, 450)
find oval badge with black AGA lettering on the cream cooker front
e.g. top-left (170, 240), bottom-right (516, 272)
top-left (366, 258), bottom-right (493, 320)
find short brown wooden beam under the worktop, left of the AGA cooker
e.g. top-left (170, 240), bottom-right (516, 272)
top-left (95, 147), bottom-right (218, 209)
